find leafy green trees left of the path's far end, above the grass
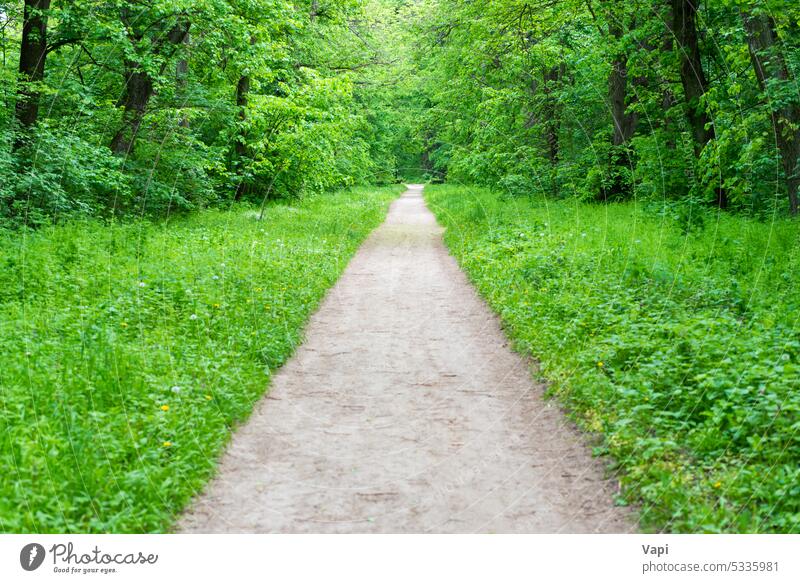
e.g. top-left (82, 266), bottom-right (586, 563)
top-left (0, 0), bottom-right (412, 226)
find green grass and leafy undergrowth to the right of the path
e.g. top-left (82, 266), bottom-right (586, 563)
top-left (426, 186), bottom-right (800, 533)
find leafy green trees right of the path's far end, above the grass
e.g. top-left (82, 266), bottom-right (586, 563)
top-left (406, 0), bottom-right (800, 216)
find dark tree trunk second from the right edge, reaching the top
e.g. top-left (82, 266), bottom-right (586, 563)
top-left (672, 0), bottom-right (728, 208)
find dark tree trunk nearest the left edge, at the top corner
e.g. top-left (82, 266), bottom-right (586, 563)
top-left (15, 0), bottom-right (50, 148)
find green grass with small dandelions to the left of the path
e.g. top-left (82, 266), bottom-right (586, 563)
top-left (0, 187), bottom-right (402, 532)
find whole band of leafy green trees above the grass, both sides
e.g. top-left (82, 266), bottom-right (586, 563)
top-left (0, 0), bottom-right (800, 224)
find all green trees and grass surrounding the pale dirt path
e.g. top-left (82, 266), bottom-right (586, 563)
top-left (0, 0), bottom-right (800, 532)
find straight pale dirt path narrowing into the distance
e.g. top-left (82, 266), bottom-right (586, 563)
top-left (179, 187), bottom-right (633, 532)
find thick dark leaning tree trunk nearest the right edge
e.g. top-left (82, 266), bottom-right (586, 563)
top-left (743, 15), bottom-right (800, 215)
